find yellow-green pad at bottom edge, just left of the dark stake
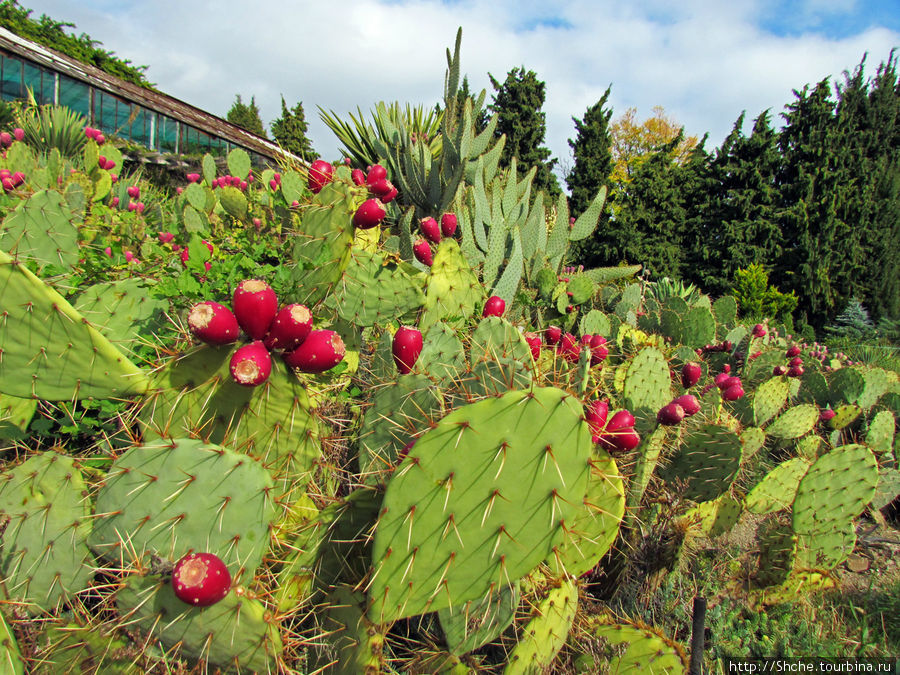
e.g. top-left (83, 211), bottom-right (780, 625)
top-left (590, 623), bottom-right (688, 675)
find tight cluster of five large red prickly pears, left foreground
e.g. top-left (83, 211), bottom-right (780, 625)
top-left (188, 279), bottom-right (344, 387)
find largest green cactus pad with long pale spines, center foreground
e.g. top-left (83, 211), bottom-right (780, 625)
top-left (369, 388), bottom-right (591, 623)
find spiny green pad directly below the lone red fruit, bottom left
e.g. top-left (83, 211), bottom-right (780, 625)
top-left (116, 575), bottom-right (282, 673)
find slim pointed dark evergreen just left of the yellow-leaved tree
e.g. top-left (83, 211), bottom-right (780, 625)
top-left (566, 88), bottom-right (613, 217)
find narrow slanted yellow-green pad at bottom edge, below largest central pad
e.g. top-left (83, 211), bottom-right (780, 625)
top-left (503, 579), bottom-right (578, 675)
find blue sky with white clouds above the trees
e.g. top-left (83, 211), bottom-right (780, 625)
top-left (19, 0), bottom-right (900, 180)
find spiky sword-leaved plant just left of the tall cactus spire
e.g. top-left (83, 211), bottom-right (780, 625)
top-left (319, 102), bottom-right (443, 167)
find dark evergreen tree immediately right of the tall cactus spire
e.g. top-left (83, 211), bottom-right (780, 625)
top-left (488, 66), bottom-right (561, 197)
